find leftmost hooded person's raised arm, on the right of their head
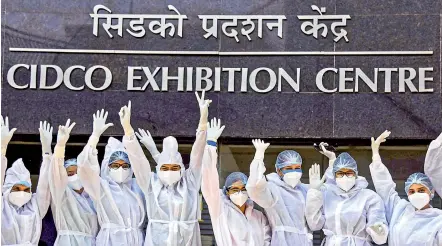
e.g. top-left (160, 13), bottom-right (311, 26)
top-left (36, 121), bottom-right (53, 218)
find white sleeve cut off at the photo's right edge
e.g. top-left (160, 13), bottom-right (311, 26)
top-left (424, 133), bottom-right (442, 196)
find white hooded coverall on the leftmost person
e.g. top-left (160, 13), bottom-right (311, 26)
top-left (1, 157), bottom-right (51, 246)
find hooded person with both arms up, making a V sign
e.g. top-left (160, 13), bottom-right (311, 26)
top-left (120, 92), bottom-right (211, 246)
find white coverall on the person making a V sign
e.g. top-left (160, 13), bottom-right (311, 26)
top-left (123, 130), bottom-right (206, 246)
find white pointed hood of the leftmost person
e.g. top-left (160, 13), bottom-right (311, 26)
top-left (2, 158), bottom-right (31, 196)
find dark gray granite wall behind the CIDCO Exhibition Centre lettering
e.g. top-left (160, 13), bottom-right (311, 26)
top-left (1, 0), bottom-right (442, 139)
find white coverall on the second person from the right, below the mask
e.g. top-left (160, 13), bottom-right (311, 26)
top-left (306, 176), bottom-right (387, 246)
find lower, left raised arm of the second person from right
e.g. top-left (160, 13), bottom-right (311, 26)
top-left (305, 164), bottom-right (326, 231)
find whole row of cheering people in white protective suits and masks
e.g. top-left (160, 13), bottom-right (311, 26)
top-left (1, 92), bottom-right (442, 246)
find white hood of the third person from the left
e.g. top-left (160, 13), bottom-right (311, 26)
top-left (101, 137), bottom-right (133, 183)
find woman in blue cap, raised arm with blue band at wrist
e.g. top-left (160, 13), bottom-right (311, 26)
top-left (201, 118), bottom-right (271, 246)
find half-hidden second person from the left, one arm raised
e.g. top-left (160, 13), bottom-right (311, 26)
top-left (49, 116), bottom-right (103, 246)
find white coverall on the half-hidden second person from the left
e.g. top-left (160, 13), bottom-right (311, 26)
top-left (49, 154), bottom-right (100, 246)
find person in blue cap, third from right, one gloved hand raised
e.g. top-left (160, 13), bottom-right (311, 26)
top-left (246, 140), bottom-right (313, 246)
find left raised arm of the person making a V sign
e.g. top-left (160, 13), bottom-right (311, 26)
top-left (119, 101), bottom-right (152, 195)
